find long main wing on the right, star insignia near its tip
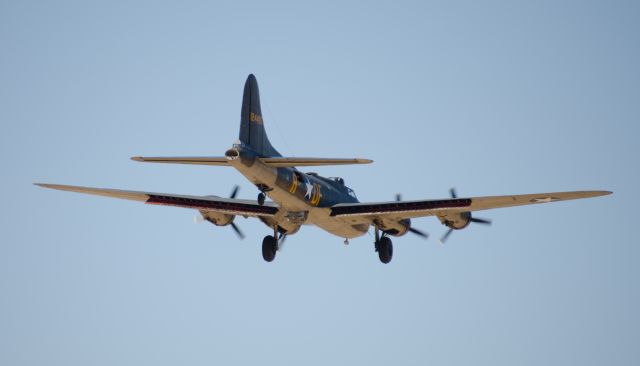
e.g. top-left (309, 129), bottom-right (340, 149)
top-left (331, 191), bottom-right (612, 222)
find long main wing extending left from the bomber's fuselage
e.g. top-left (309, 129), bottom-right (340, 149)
top-left (34, 183), bottom-right (278, 217)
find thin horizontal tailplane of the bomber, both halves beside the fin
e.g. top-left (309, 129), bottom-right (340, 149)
top-left (131, 156), bottom-right (373, 168)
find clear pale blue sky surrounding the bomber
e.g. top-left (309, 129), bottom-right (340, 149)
top-left (0, 1), bottom-right (640, 366)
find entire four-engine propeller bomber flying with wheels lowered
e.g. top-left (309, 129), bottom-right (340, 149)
top-left (36, 75), bottom-right (611, 263)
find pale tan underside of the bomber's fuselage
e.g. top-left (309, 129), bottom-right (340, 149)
top-left (231, 161), bottom-right (369, 238)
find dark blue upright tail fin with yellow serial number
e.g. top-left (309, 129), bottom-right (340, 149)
top-left (240, 74), bottom-right (281, 157)
